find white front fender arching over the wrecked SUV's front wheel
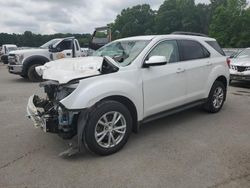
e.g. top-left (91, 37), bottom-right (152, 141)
top-left (60, 74), bottom-right (143, 120)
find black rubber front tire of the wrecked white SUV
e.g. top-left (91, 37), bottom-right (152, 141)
top-left (83, 100), bottom-right (132, 155)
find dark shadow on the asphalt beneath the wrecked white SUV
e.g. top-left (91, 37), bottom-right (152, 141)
top-left (63, 107), bottom-right (205, 162)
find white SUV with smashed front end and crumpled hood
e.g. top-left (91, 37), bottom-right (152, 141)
top-left (27, 34), bottom-right (229, 155)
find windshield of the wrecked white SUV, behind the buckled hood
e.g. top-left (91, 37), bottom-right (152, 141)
top-left (92, 40), bottom-right (150, 66)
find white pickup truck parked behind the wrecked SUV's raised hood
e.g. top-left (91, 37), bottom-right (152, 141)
top-left (8, 37), bottom-right (81, 81)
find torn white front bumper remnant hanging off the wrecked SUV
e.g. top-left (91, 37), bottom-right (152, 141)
top-left (27, 95), bottom-right (46, 132)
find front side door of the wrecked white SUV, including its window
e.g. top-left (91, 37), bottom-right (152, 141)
top-left (142, 40), bottom-right (187, 118)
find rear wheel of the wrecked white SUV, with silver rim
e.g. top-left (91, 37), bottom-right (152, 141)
top-left (204, 81), bottom-right (226, 113)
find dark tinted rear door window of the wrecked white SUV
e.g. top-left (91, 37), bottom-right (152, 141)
top-left (178, 40), bottom-right (210, 61)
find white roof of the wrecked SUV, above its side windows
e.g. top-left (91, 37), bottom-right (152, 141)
top-left (118, 34), bottom-right (215, 41)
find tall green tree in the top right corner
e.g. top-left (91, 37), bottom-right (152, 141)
top-left (209, 0), bottom-right (249, 47)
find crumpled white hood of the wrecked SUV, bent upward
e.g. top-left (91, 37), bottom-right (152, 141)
top-left (36, 57), bottom-right (104, 84)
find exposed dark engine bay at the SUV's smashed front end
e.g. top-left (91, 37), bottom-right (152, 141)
top-left (33, 81), bottom-right (79, 139)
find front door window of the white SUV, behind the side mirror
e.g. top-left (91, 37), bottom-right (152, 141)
top-left (148, 40), bottom-right (179, 63)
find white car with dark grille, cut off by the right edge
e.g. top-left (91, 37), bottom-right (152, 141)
top-left (230, 48), bottom-right (250, 81)
